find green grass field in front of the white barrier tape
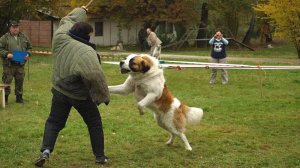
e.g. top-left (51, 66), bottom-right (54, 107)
top-left (0, 48), bottom-right (300, 168)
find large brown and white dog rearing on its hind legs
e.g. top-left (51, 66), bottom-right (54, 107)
top-left (109, 54), bottom-right (203, 150)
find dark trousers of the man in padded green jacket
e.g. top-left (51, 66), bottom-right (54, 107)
top-left (41, 89), bottom-right (104, 157)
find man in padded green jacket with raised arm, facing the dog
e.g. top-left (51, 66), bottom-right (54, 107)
top-left (35, 6), bottom-right (110, 167)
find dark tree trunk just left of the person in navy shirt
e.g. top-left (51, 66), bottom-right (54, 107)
top-left (196, 3), bottom-right (208, 48)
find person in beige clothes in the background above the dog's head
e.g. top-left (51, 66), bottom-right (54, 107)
top-left (147, 28), bottom-right (162, 57)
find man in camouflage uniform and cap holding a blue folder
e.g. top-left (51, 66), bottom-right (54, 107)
top-left (0, 21), bottom-right (32, 104)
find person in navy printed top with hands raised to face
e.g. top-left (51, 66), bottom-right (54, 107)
top-left (209, 31), bottom-right (228, 85)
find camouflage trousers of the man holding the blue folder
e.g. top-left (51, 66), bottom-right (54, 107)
top-left (2, 64), bottom-right (25, 95)
